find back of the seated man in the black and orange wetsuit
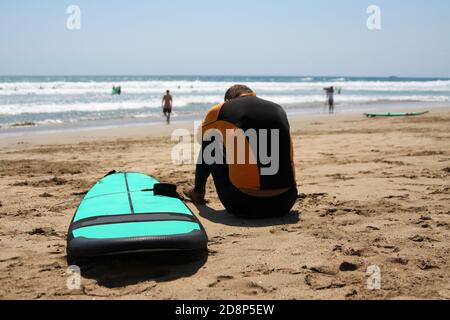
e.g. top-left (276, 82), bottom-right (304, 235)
top-left (203, 96), bottom-right (295, 191)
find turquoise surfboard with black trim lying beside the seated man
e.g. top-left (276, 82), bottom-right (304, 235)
top-left (67, 172), bottom-right (208, 257)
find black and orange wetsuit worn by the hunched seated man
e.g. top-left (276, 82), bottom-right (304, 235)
top-left (195, 96), bottom-right (297, 218)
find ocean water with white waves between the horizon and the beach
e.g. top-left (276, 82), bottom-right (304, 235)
top-left (0, 76), bottom-right (450, 130)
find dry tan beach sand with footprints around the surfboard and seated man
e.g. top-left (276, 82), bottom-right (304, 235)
top-left (0, 108), bottom-right (450, 299)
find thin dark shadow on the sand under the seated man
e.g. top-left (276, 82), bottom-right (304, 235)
top-left (197, 206), bottom-right (300, 228)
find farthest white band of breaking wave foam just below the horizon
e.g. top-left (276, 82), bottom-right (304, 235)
top-left (0, 78), bottom-right (450, 96)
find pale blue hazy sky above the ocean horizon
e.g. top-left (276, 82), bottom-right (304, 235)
top-left (0, 0), bottom-right (450, 77)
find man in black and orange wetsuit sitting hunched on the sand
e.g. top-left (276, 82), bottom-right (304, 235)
top-left (185, 85), bottom-right (297, 218)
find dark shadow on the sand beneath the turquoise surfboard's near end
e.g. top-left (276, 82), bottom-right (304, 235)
top-left (67, 250), bottom-right (208, 288)
